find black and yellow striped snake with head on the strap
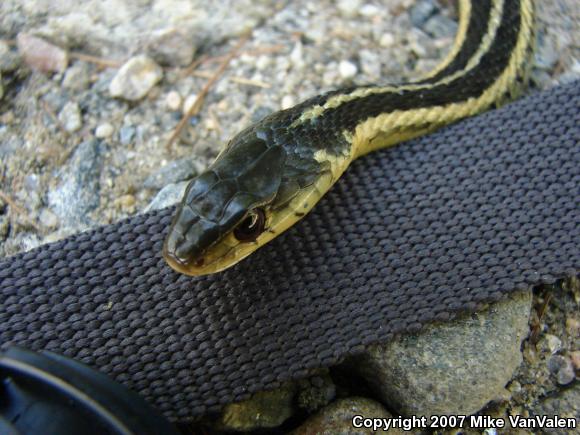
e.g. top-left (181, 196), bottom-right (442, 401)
top-left (163, 0), bottom-right (535, 276)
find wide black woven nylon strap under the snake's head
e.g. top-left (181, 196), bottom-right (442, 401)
top-left (0, 82), bottom-right (580, 420)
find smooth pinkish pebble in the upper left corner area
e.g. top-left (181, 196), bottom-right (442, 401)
top-left (16, 32), bottom-right (68, 72)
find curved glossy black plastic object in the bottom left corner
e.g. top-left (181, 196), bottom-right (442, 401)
top-left (0, 346), bottom-right (178, 435)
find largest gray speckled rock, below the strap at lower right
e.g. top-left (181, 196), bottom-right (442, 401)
top-left (352, 292), bottom-right (531, 417)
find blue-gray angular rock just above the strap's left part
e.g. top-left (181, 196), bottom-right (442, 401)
top-left (48, 140), bottom-right (103, 227)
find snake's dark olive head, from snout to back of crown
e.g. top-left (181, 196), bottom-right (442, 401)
top-left (163, 130), bottom-right (285, 276)
